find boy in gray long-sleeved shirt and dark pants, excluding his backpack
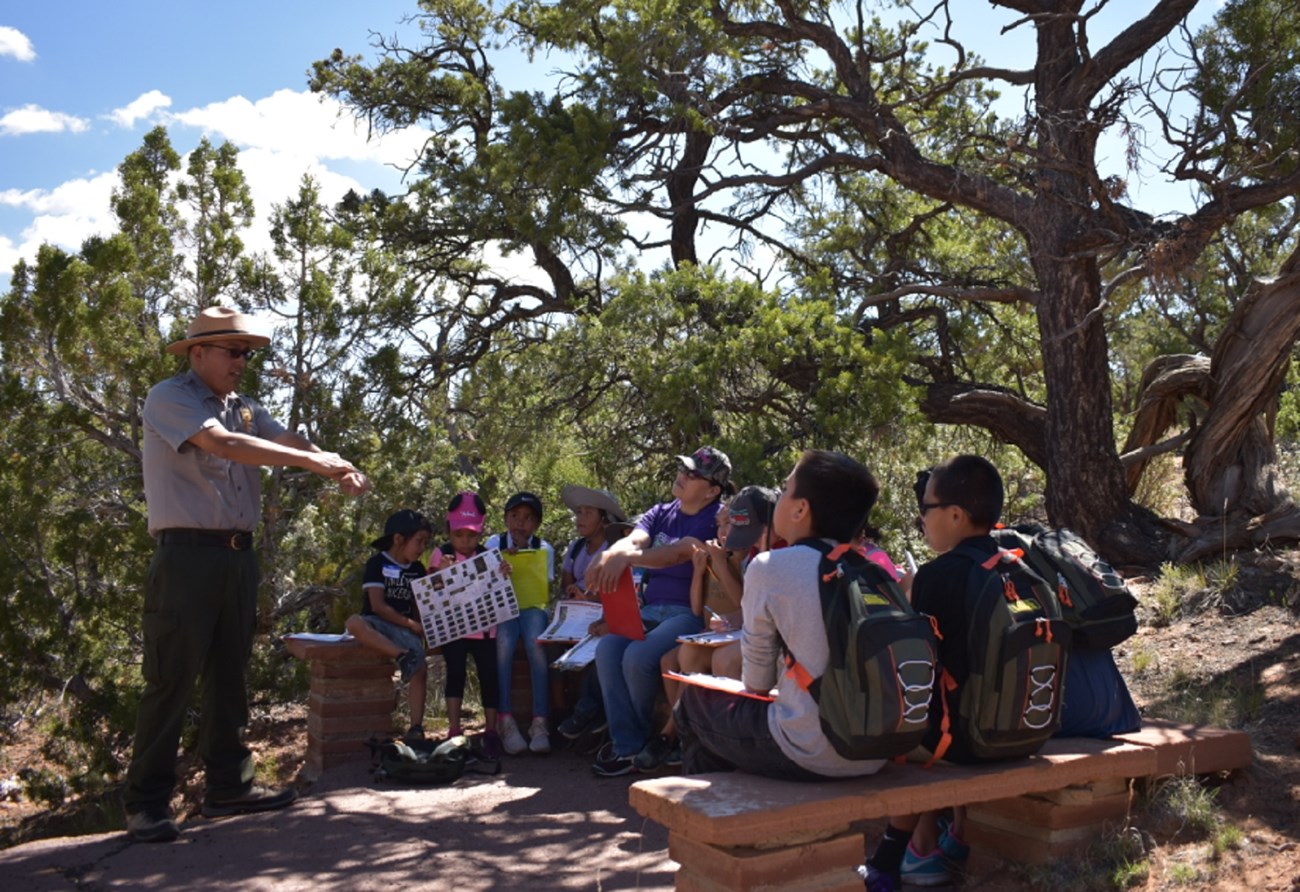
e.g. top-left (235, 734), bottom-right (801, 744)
top-left (675, 450), bottom-right (933, 780)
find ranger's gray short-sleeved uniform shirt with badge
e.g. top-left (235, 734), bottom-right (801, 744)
top-left (144, 371), bottom-right (285, 536)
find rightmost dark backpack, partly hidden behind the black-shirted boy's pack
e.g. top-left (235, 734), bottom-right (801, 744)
top-left (992, 524), bottom-right (1138, 650)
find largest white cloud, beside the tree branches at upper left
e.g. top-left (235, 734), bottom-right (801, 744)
top-left (170, 90), bottom-right (429, 166)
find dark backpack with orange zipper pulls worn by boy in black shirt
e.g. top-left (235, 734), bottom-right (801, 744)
top-left (935, 544), bottom-right (1070, 761)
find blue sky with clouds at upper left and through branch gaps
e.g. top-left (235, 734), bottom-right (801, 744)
top-left (0, 0), bottom-right (1222, 290)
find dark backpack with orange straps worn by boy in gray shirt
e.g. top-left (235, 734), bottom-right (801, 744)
top-left (785, 538), bottom-right (937, 759)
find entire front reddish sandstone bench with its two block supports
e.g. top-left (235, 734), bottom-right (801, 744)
top-left (628, 719), bottom-right (1251, 892)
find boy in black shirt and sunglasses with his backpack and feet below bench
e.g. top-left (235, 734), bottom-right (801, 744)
top-left (861, 455), bottom-right (1070, 889)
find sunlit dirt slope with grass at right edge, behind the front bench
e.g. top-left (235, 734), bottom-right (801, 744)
top-left (1102, 553), bottom-right (1300, 891)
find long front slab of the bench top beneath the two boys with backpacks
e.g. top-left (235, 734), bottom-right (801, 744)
top-left (628, 739), bottom-right (1157, 846)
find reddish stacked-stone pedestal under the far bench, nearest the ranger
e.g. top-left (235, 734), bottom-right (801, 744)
top-left (286, 638), bottom-right (397, 779)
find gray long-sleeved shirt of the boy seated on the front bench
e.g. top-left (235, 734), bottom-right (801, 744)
top-left (741, 545), bottom-right (884, 778)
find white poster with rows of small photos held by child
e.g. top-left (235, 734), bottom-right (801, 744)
top-left (411, 549), bottom-right (519, 648)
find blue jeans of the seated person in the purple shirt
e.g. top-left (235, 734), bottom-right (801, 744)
top-left (595, 603), bottom-right (703, 755)
